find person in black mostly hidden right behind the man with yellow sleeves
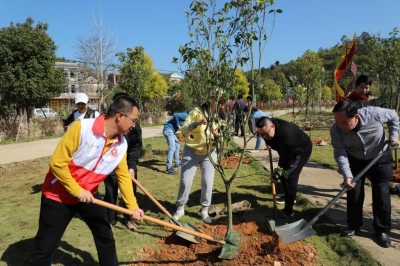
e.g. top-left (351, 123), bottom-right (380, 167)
top-left (104, 93), bottom-right (143, 230)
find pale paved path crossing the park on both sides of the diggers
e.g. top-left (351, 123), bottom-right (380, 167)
top-left (0, 122), bottom-right (400, 266)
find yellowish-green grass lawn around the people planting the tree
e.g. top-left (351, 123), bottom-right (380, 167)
top-left (0, 132), bottom-right (378, 265)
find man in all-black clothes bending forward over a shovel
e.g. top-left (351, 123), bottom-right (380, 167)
top-left (256, 117), bottom-right (312, 217)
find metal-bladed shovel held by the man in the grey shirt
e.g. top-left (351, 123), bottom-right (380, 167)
top-left (275, 142), bottom-right (397, 244)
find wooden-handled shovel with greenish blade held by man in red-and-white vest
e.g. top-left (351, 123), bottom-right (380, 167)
top-left (93, 199), bottom-right (240, 259)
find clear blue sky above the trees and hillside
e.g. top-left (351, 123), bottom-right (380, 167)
top-left (0, 0), bottom-right (400, 73)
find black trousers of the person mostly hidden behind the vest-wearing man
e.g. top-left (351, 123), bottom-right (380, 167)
top-left (104, 167), bottom-right (137, 225)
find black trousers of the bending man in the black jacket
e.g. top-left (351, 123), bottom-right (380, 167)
top-left (281, 149), bottom-right (312, 213)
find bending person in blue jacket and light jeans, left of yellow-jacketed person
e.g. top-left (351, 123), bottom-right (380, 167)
top-left (163, 112), bottom-right (187, 175)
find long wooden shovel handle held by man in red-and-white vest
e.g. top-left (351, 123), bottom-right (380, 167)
top-left (94, 199), bottom-right (226, 245)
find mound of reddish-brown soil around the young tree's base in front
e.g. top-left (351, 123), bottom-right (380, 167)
top-left (133, 222), bottom-right (317, 266)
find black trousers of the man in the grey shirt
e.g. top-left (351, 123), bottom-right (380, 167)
top-left (347, 153), bottom-right (393, 233)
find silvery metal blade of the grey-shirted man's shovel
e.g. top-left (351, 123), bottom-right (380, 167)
top-left (275, 219), bottom-right (317, 244)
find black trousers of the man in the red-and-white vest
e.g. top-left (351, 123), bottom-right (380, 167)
top-left (30, 193), bottom-right (118, 266)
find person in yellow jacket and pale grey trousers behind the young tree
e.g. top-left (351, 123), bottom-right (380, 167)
top-left (174, 103), bottom-right (219, 223)
